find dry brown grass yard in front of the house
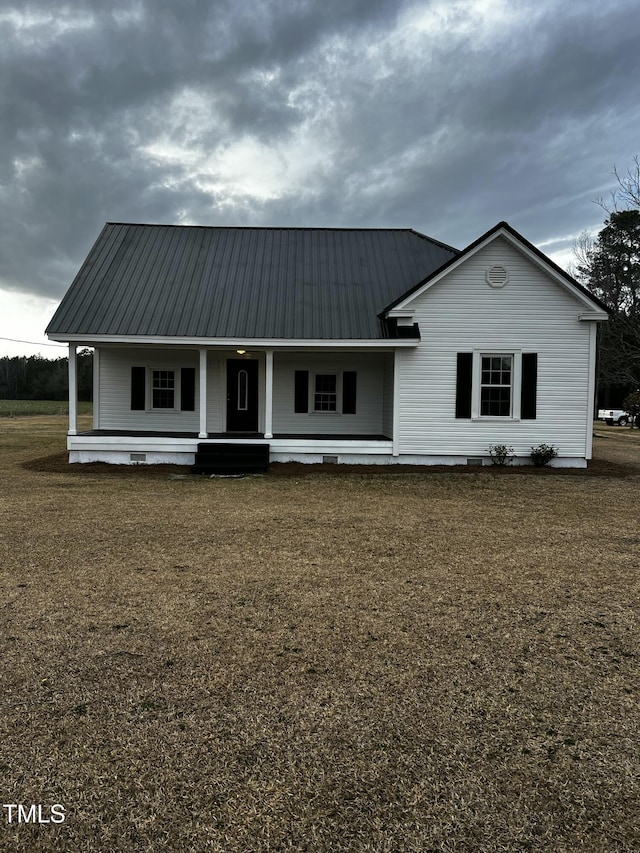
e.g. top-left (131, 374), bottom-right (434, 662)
top-left (0, 417), bottom-right (640, 853)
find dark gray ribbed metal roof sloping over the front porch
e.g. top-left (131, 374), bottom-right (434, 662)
top-left (47, 223), bottom-right (457, 340)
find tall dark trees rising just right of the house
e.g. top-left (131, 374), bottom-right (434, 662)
top-left (574, 156), bottom-right (640, 409)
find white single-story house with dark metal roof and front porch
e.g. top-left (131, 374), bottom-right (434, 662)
top-left (47, 222), bottom-right (608, 467)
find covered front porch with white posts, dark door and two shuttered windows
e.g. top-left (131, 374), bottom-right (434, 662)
top-left (67, 345), bottom-right (410, 465)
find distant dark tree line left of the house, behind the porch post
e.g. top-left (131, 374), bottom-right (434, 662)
top-left (0, 349), bottom-right (93, 401)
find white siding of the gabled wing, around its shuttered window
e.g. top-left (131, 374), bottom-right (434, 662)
top-left (398, 238), bottom-right (592, 457)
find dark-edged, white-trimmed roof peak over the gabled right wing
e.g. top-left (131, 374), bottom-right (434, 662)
top-left (382, 222), bottom-right (608, 319)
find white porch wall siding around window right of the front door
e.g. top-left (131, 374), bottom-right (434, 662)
top-left (273, 352), bottom-right (387, 435)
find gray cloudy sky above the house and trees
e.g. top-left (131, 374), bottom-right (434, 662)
top-left (0, 0), bottom-right (640, 357)
